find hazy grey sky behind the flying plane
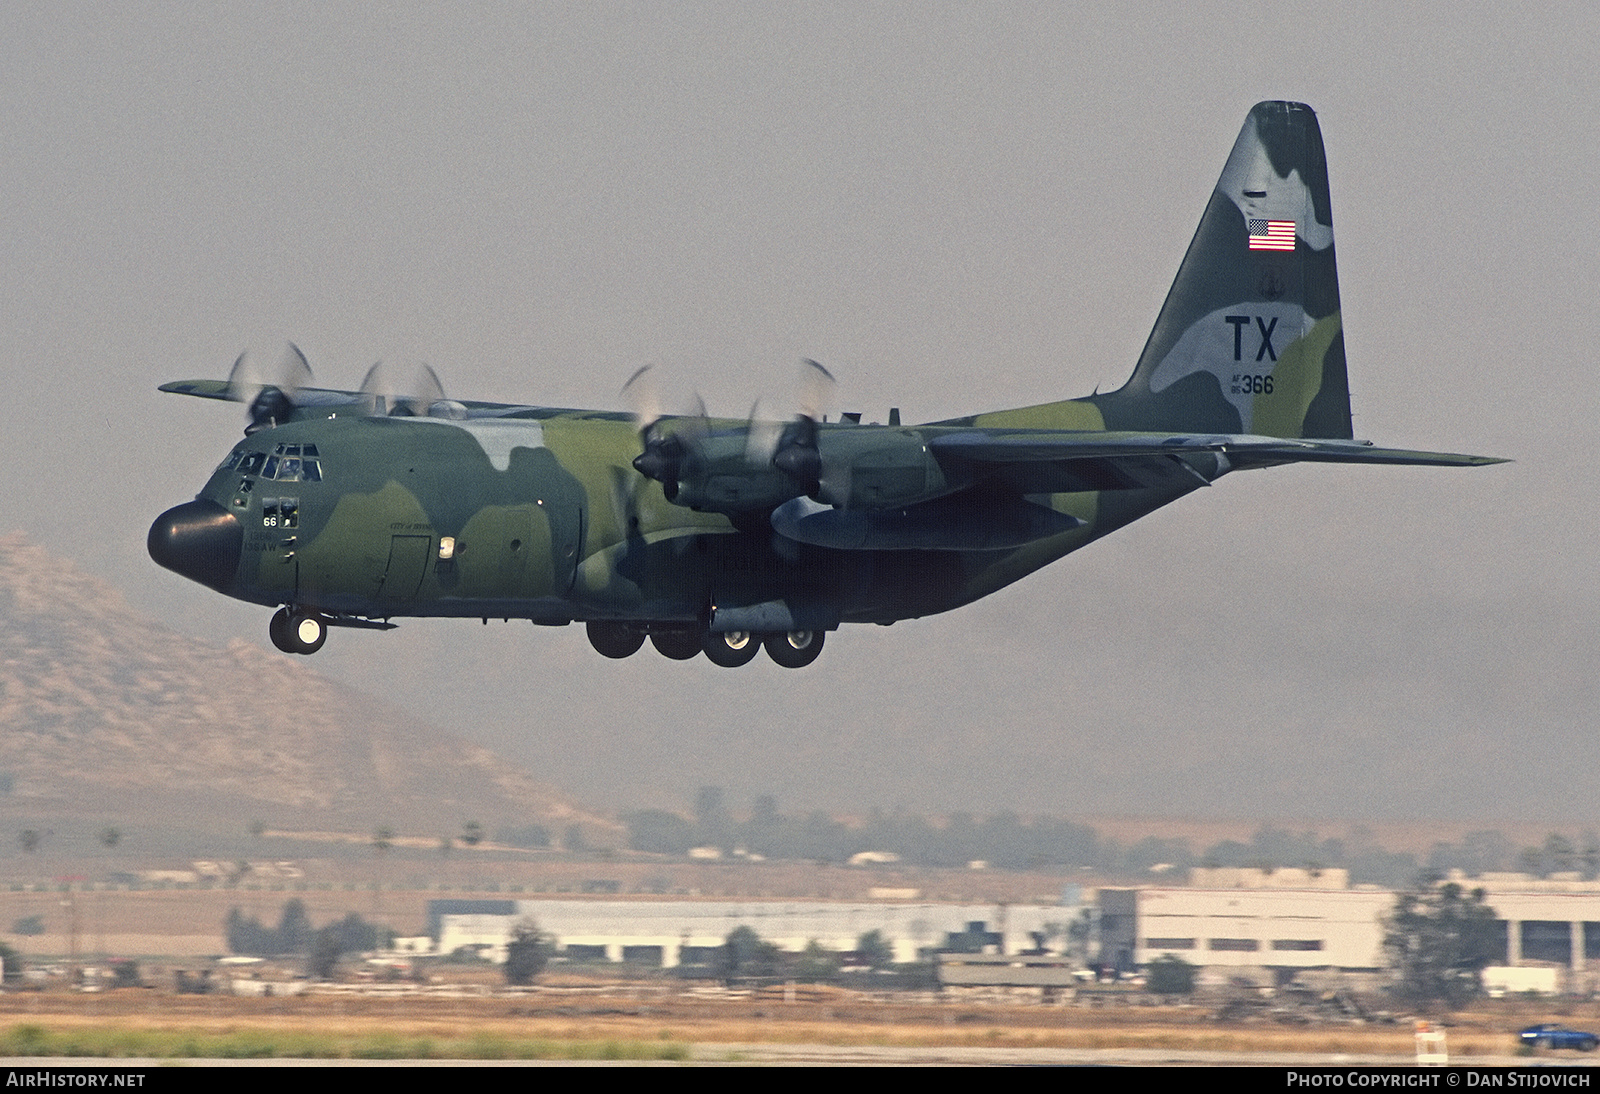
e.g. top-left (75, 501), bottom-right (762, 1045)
top-left (0, 2), bottom-right (1600, 825)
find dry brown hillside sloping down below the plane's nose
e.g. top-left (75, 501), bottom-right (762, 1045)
top-left (0, 534), bottom-right (611, 833)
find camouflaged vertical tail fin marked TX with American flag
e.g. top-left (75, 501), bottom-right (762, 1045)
top-left (1088, 102), bottom-right (1352, 438)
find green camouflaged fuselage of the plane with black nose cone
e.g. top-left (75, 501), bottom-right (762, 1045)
top-left (150, 411), bottom-right (1187, 630)
